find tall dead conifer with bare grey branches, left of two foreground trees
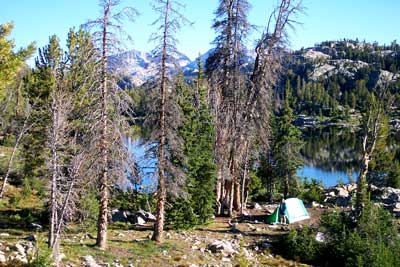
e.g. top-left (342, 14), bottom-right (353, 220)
top-left (85, 0), bottom-right (137, 249)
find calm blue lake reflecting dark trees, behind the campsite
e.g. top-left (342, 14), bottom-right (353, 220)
top-left (126, 127), bottom-right (400, 190)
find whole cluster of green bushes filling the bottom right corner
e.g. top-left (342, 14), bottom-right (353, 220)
top-left (281, 203), bottom-right (400, 267)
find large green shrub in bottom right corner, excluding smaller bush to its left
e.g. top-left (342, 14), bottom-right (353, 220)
top-left (321, 203), bottom-right (400, 267)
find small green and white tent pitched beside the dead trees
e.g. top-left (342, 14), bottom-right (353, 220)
top-left (265, 198), bottom-right (310, 224)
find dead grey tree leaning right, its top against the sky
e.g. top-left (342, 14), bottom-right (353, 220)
top-left (236, 0), bottom-right (302, 214)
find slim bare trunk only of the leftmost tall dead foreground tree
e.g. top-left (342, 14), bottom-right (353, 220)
top-left (96, 13), bottom-right (110, 249)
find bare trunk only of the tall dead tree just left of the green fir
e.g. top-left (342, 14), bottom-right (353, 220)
top-left (152, 0), bottom-right (170, 243)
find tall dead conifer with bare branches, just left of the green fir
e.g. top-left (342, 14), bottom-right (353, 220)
top-left (150, 0), bottom-right (188, 243)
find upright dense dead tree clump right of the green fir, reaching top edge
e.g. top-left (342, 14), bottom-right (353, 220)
top-left (206, 0), bottom-right (250, 217)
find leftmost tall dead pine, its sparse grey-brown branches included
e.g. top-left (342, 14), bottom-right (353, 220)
top-left (85, 0), bottom-right (137, 249)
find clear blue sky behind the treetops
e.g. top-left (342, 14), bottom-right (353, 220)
top-left (0, 0), bottom-right (400, 59)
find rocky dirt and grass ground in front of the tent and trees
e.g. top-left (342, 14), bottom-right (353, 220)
top-left (0, 194), bottom-right (326, 267)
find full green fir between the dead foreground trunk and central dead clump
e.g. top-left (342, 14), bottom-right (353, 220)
top-left (167, 64), bottom-right (216, 228)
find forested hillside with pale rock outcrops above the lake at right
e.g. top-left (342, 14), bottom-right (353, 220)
top-left (286, 40), bottom-right (400, 120)
